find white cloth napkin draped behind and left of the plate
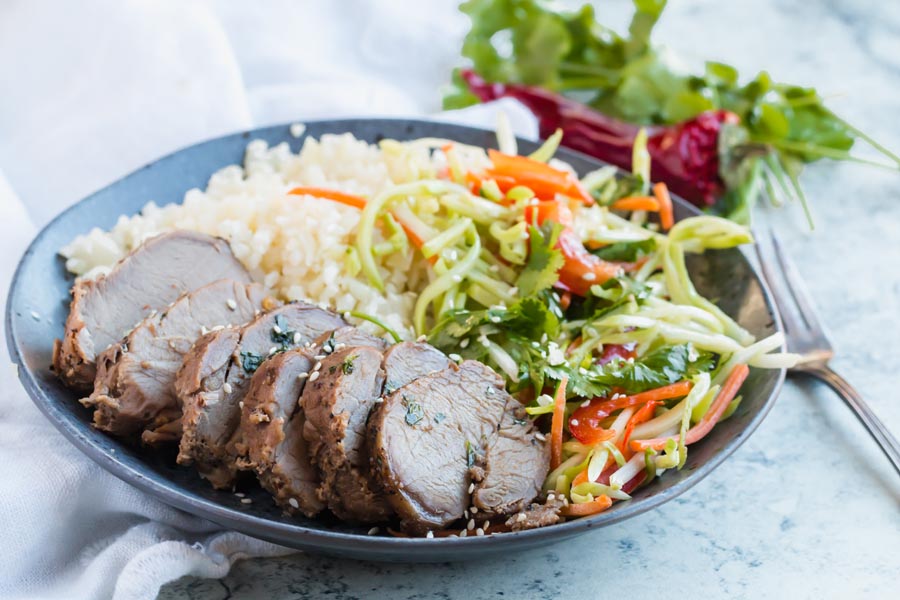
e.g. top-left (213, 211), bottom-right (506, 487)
top-left (0, 0), bottom-right (536, 600)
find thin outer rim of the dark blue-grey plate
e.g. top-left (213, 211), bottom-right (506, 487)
top-left (4, 117), bottom-right (786, 562)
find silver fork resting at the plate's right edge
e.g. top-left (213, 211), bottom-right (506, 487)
top-left (756, 232), bottom-right (900, 474)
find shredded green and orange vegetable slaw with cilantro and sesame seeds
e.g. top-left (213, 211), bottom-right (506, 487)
top-left (292, 123), bottom-right (796, 517)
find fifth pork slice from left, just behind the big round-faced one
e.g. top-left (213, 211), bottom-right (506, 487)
top-left (300, 346), bottom-right (392, 523)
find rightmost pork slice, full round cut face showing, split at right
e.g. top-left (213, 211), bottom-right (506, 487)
top-left (368, 361), bottom-right (548, 533)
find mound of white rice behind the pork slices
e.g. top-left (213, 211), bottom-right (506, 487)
top-left (60, 133), bottom-right (428, 338)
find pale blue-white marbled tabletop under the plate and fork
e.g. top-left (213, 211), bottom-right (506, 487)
top-left (160, 0), bottom-right (900, 600)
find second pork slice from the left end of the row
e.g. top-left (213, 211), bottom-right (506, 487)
top-left (82, 279), bottom-right (273, 435)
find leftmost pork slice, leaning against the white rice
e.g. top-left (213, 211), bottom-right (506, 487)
top-left (53, 231), bottom-right (250, 391)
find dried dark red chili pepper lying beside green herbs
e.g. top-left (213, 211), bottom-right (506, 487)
top-left (462, 70), bottom-right (740, 206)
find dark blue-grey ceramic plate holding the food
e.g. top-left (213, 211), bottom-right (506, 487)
top-left (6, 119), bottom-right (784, 562)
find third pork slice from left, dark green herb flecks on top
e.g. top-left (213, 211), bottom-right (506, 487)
top-left (176, 302), bottom-right (345, 488)
